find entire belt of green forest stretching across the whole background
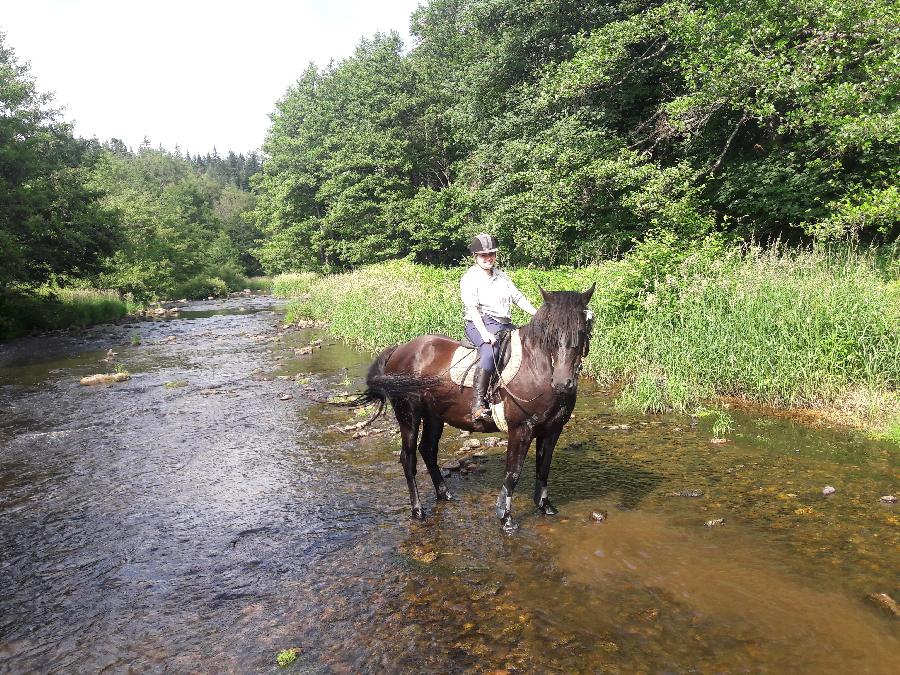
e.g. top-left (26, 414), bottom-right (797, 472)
top-left (0, 0), bottom-right (900, 312)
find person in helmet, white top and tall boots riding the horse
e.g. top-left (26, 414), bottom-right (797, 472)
top-left (459, 233), bottom-right (537, 420)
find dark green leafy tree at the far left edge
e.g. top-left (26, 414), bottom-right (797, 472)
top-left (0, 33), bottom-right (117, 289)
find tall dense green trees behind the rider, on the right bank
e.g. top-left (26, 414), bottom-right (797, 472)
top-left (255, 0), bottom-right (900, 272)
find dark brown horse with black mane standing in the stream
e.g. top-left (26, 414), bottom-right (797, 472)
top-left (357, 286), bottom-right (594, 531)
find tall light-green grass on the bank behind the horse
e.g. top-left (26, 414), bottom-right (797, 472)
top-left (274, 238), bottom-right (900, 435)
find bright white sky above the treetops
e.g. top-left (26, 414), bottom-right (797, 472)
top-left (0, 0), bottom-right (424, 154)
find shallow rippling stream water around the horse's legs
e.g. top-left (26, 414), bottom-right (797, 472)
top-left (0, 298), bottom-right (900, 673)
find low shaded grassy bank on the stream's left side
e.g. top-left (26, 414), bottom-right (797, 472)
top-left (0, 288), bottom-right (136, 340)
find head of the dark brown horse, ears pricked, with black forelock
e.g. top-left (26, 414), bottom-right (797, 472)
top-left (533, 284), bottom-right (597, 394)
